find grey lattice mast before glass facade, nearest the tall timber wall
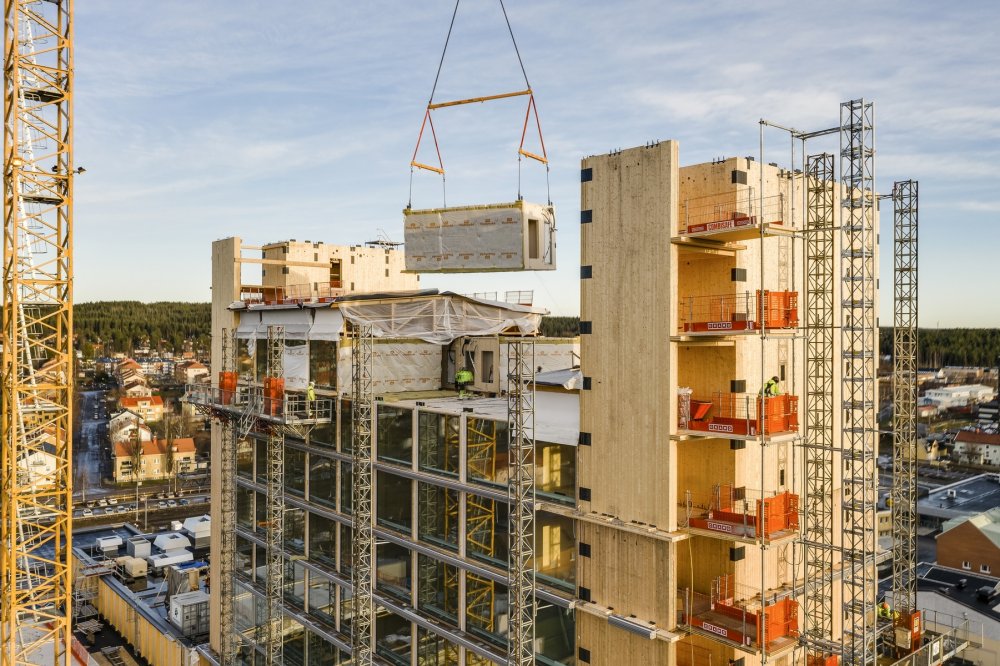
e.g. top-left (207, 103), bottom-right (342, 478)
top-left (507, 339), bottom-right (535, 666)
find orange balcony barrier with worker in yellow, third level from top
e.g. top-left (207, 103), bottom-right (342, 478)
top-left (678, 392), bottom-right (799, 437)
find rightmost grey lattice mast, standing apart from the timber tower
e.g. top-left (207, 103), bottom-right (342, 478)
top-left (891, 180), bottom-right (918, 615)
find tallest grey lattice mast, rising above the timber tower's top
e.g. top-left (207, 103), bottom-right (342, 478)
top-left (840, 99), bottom-right (878, 666)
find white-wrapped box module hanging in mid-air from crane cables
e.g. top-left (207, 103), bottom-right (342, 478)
top-left (403, 201), bottom-right (556, 273)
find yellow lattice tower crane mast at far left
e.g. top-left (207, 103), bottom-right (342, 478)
top-left (0, 0), bottom-right (74, 665)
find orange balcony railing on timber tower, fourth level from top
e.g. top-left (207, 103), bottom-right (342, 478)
top-left (681, 484), bottom-right (799, 539)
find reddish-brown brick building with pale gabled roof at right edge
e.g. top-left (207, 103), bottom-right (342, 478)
top-left (937, 507), bottom-right (1000, 575)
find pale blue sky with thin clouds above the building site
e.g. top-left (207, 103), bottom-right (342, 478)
top-left (75, 0), bottom-right (1000, 327)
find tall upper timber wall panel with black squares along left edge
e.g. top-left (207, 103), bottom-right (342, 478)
top-left (577, 141), bottom-right (677, 530)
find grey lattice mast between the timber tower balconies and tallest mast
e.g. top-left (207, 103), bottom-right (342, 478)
top-left (802, 148), bottom-right (835, 652)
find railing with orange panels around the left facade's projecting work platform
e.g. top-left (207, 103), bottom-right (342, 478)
top-left (184, 377), bottom-right (334, 424)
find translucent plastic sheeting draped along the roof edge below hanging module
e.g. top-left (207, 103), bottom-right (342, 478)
top-left (340, 294), bottom-right (545, 345)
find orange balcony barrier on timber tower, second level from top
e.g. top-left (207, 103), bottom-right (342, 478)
top-left (679, 289), bottom-right (799, 334)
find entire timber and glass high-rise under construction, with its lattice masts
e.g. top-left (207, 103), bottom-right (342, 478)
top-left (189, 101), bottom-right (966, 666)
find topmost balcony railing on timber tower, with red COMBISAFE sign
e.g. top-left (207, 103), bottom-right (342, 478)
top-left (678, 188), bottom-right (786, 235)
